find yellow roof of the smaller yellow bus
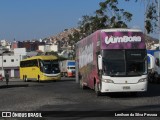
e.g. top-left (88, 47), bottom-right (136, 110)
top-left (22, 55), bottom-right (58, 61)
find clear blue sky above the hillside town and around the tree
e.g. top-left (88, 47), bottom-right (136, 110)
top-left (0, 0), bottom-right (152, 41)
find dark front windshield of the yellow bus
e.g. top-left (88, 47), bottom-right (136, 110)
top-left (40, 60), bottom-right (60, 74)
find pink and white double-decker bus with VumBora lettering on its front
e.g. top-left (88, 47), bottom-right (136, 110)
top-left (76, 29), bottom-right (148, 95)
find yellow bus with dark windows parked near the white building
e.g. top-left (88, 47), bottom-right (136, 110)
top-left (20, 55), bottom-right (61, 82)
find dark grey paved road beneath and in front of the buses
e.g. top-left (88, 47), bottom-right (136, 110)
top-left (0, 78), bottom-right (160, 119)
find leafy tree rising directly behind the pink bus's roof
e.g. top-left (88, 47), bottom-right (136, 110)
top-left (78, 0), bottom-right (132, 38)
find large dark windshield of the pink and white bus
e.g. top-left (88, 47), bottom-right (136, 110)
top-left (103, 50), bottom-right (147, 76)
